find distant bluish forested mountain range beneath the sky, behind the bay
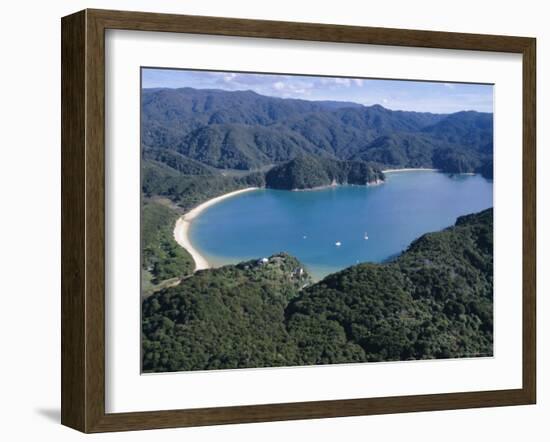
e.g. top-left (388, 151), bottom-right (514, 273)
top-left (141, 88), bottom-right (493, 176)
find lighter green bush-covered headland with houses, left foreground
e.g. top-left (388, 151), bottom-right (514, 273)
top-left (142, 254), bottom-right (310, 372)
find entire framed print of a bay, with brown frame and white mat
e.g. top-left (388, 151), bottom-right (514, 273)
top-left (62, 10), bottom-right (536, 432)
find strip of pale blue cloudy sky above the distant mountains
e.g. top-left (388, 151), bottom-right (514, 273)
top-left (142, 68), bottom-right (493, 113)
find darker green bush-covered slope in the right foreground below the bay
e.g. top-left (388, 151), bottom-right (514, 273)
top-left (287, 210), bottom-right (493, 364)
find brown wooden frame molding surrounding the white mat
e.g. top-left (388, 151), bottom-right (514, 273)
top-left (61, 10), bottom-right (536, 432)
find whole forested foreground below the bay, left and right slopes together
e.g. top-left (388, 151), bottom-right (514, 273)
top-left (142, 209), bottom-right (493, 372)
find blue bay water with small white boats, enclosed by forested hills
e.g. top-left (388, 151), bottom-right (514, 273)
top-left (190, 171), bottom-right (493, 279)
